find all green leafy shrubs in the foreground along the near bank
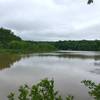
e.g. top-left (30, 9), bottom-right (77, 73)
top-left (8, 79), bottom-right (100, 100)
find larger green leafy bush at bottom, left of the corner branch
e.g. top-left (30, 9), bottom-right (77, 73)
top-left (8, 79), bottom-right (74, 100)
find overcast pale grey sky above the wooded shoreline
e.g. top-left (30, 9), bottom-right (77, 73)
top-left (0, 0), bottom-right (100, 41)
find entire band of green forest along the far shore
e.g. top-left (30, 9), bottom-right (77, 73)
top-left (0, 28), bottom-right (100, 53)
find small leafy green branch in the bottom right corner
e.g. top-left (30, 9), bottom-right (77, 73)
top-left (82, 80), bottom-right (100, 100)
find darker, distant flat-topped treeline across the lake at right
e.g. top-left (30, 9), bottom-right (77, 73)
top-left (54, 40), bottom-right (100, 51)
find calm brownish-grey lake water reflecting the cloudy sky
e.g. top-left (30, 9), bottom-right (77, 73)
top-left (0, 51), bottom-right (100, 100)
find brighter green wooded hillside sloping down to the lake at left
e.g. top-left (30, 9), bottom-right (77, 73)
top-left (0, 28), bottom-right (56, 53)
